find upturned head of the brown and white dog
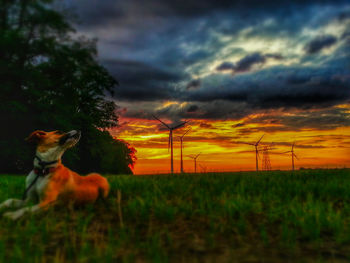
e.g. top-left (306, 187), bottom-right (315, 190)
top-left (26, 130), bottom-right (81, 158)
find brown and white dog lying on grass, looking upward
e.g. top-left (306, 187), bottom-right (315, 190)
top-left (0, 130), bottom-right (109, 220)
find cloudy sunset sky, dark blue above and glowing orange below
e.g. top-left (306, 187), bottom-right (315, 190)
top-left (62, 0), bottom-right (350, 174)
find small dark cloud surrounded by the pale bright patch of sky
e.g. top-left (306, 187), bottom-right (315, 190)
top-left (216, 52), bottom-right (283, 73)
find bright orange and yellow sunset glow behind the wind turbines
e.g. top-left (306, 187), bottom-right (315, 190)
top-left (111, 116), bottom-right (350, 174)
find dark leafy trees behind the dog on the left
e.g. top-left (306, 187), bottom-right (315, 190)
top-left (0, 0), bottom-right (136, 174)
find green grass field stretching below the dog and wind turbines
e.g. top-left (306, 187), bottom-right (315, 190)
top-left (0, 169), bottom-right (350, 263)
